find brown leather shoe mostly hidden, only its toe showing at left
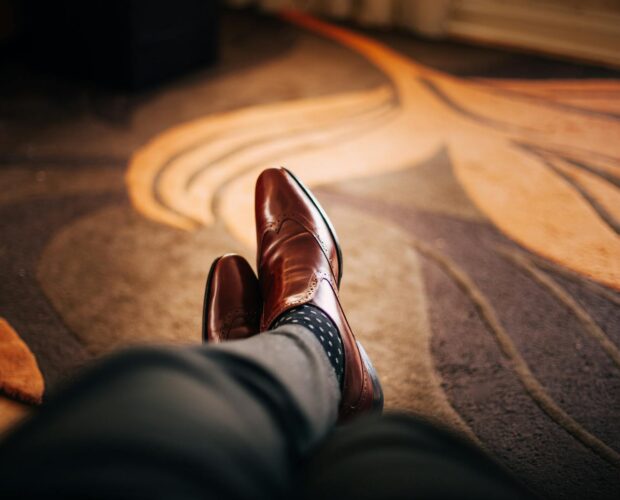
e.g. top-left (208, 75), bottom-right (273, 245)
top-left (202, 254), bottom-right (261, 343)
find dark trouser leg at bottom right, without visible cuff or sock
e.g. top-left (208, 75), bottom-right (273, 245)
top-left (297, 414), bottom-right (532, 500)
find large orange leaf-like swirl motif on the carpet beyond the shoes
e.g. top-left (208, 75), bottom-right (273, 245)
top-left (127, 12), bottom-right (620, 288)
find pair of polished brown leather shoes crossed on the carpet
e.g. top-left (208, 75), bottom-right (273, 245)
top-left (203, 168), bottom-right (383, 420)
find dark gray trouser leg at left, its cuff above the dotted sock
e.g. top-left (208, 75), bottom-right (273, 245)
top-left (0, 326), bottom-right (339, 499)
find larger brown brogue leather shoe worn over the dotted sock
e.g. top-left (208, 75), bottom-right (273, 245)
top-left (255, 168), bottom-right (383, 421)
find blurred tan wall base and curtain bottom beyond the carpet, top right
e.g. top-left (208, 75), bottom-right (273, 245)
top-left (226, 0), bottom-right (620, 67)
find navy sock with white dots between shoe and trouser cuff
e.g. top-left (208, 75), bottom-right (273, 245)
top-left (271, 304), bottom-right (344, 387)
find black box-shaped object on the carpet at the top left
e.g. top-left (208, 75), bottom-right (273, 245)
top-left (22, 0), bottom-right (218, 89)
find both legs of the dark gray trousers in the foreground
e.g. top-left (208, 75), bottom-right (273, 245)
top-left (0, 326), bottom-right (527, 500)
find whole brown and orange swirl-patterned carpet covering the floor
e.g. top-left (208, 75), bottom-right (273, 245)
top-left (0, 8), bottom-right (620, 498)
